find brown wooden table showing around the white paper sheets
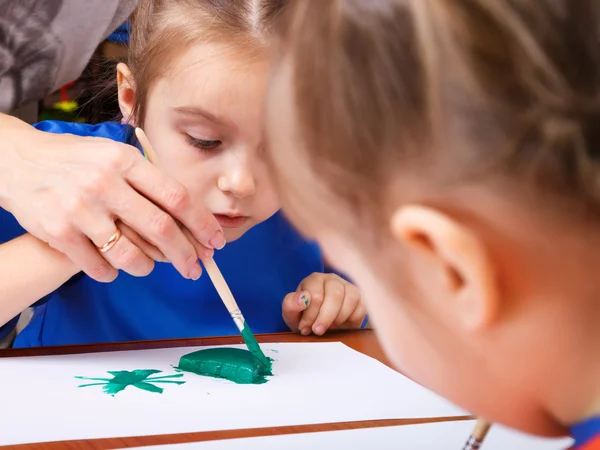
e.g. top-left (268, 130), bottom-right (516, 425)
top-left (0, 330), bottom-right (472, 450)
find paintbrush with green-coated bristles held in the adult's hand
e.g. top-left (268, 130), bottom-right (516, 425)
top-left (135, 127), bottom-right (271, 372)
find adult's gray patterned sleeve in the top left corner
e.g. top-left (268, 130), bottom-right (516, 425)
top-left (0, 0), bottom-right (137, 112)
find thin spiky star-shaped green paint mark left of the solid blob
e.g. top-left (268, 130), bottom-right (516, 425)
top-left (75, 369), bottom-right (185, 397)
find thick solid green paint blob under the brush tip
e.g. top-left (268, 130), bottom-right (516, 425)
top-left (178, 347), bottom-right (272, 384)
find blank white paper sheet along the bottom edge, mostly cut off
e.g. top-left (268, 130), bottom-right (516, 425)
top-left (120, 421), bottom-right (572, 450)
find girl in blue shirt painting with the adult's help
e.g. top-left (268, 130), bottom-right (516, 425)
top-left (0, 0), bottom-right (365, 347)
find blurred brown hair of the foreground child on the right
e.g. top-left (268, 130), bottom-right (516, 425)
top-left (271, 0), bottom-right (600, 239)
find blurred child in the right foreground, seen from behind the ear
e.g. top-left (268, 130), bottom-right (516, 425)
top-left (267, 0), bottom-right (600, 449)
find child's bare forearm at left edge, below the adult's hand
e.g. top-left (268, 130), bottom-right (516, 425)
top-left (0, 234), bottom-right (79, 325)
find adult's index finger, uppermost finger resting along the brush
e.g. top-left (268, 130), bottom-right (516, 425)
top-left (125, 154), bottom-right (225, 249)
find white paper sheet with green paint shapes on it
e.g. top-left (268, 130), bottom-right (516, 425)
top-left (0, 342), bottom-right (465, 445)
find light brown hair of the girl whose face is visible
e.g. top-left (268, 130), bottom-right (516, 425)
top-left (127, 0), bottom-right (287, 123)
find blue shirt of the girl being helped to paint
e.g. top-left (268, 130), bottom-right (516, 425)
top-left (0, 122), bottom-right (325, 347)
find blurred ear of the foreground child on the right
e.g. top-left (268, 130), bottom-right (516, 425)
top-left (390, 206), bottom-right (499, 331)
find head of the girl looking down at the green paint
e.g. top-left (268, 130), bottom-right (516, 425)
top-left (118, 0), bottom-right (284, 241)
